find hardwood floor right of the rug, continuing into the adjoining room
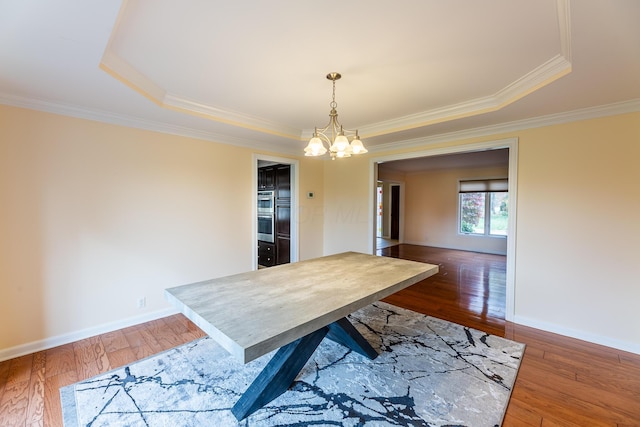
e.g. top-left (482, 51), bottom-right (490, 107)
top-left (378, 245), bottom-right (640, 427)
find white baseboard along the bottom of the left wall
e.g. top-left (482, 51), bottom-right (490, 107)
top-left (0, 308), bottom-right (178, 362)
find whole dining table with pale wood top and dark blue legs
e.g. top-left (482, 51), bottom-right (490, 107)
top-left (165, 252), bottom-right (438, 420)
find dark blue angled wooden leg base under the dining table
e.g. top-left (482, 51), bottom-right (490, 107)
top-left (231, 317), bottom-right (378, 420)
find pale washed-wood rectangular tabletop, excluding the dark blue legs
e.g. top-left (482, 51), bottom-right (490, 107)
top-left (165, 252), bottom-right (438, 363)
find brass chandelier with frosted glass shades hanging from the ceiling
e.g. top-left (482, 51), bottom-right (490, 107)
top-left (304, 73), bottom-right (368, 160)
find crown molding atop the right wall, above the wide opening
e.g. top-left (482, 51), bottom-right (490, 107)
top-left (368, 98), bottom-right (640, 153)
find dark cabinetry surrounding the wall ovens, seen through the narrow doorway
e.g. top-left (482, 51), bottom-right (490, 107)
top-left (258, 164), bottom-right (291, 267)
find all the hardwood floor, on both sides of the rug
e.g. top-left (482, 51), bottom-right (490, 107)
top-left (0, 245), bottom-right (640, 427)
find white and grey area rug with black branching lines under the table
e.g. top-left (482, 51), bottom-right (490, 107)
top-left (61, 302), bottom-right (524, 427)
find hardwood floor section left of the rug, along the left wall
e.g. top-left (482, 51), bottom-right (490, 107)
top-left (0, 315), bottom-right (205, 427)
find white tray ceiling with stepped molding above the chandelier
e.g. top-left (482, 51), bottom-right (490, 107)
top-left (0, 0), bottom-right (640, 154)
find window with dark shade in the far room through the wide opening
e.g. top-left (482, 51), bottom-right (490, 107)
top-left (459, 179), bottom-right (509, 236)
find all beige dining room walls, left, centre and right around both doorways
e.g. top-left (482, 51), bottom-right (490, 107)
top-left (0, 106), bottom-right (640, 356)
